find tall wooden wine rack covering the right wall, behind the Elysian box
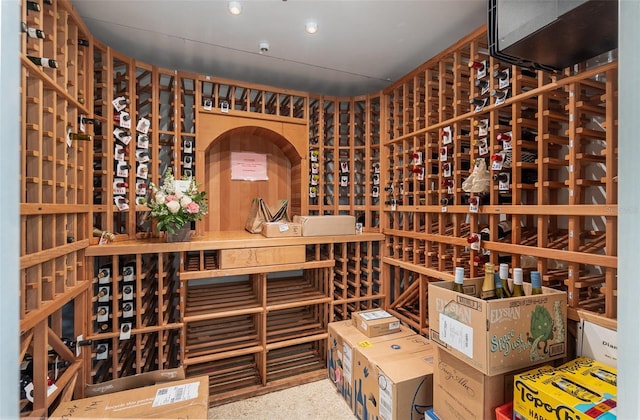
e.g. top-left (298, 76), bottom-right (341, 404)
top-left (382, 28), bottom-right (617, 332)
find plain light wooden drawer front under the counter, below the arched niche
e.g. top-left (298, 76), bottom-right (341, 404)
top-left (219, 245), bottom-right (306, 270)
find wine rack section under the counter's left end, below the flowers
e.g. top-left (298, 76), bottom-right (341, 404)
top-left (86, 253), bottom-right (182, 383)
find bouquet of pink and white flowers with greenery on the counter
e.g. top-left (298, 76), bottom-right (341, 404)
top-left (147, 168), bottom-right (208, 234)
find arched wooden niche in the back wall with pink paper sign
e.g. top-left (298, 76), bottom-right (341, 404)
top-left (196, 115), bottom-right (308, 232)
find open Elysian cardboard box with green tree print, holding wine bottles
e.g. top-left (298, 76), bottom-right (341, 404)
top-left (429, 278), bottom-right (567, 376)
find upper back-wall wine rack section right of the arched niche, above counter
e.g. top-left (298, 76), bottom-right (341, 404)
top-left (308, 96), bottom-right (382, 228)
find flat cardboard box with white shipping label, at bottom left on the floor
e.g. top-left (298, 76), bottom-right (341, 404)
top-left (50, 376), bottom-right (209, 419)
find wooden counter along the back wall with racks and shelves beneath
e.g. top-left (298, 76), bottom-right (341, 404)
top-left (87, 232), bottom-right (385, 405)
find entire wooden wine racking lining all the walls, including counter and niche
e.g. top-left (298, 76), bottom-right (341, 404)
top-left (20, 0), bottom-right (618, 416)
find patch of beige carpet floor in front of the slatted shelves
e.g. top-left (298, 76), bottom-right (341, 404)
top-left (209, 379), bottom-right (355, 420)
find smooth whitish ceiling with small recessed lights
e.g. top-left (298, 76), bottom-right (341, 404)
top-left (72, 0), bottom-right (488, 96)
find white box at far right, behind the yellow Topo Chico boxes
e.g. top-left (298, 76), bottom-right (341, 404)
top-left (576, 320), bottom-right (618, 367)
